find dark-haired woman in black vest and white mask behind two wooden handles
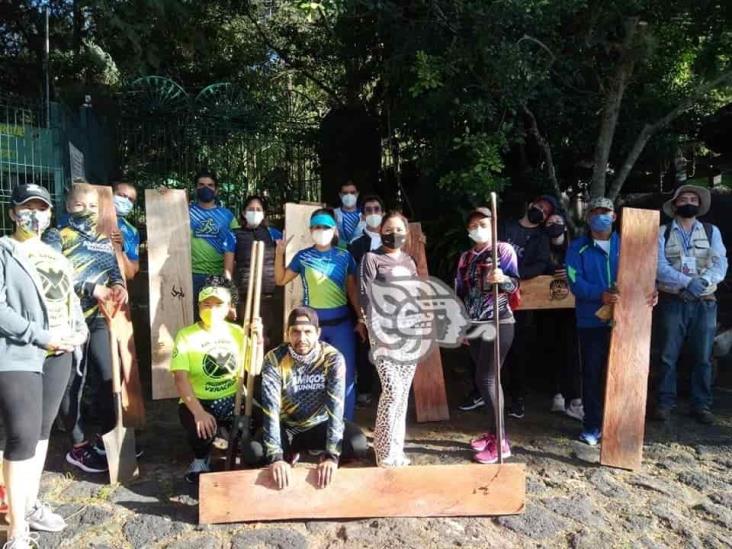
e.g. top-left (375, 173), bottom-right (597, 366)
top-left (234, 196), bottom-right (283, 348)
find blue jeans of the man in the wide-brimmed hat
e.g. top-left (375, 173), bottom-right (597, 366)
top-left (656, 296), bottom-right (717, 411)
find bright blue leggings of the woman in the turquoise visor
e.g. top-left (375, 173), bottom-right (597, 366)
top-left (315, 306), bottom-right (356, 421)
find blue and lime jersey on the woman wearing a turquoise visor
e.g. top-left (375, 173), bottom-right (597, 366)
top-left (287, 246), bottom-right (356, 309)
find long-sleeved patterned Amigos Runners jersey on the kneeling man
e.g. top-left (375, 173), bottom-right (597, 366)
top-left (262, 341), bottom-right (346, 462)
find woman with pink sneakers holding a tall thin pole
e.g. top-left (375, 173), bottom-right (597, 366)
top-left (455, 208), bottom-right (519, 463)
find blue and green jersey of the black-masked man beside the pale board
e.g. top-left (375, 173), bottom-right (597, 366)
top-left (188, 203), bottom-right (239, 275)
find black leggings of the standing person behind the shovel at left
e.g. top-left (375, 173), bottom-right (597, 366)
top-left (61, 316), bottom-right (115, 444)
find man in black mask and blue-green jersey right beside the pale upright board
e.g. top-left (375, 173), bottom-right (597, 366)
top-left (188, 170), bottom-right (239, 318)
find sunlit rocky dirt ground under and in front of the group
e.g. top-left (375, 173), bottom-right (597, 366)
top-left (2, 358), bottom-right (732, 549)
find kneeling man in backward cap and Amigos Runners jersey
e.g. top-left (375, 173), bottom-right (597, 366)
top-left (245, 307), bottom-right (368, 489)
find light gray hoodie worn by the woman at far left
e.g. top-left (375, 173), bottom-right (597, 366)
top-left (0, 236), bottom-right (51, 372)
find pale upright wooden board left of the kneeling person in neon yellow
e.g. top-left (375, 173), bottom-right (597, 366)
top-left (145, 189), bottom-right (193, 400)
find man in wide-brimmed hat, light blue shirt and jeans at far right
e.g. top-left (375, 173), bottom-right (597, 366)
top-left (653, 185), bottom-right (727, 424)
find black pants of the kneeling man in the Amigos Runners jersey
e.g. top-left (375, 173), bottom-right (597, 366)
top-left (243, 420), bottom-right (369, 467)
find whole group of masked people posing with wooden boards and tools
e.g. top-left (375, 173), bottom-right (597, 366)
top-left (0, 172), bottom-right (727, 548)
